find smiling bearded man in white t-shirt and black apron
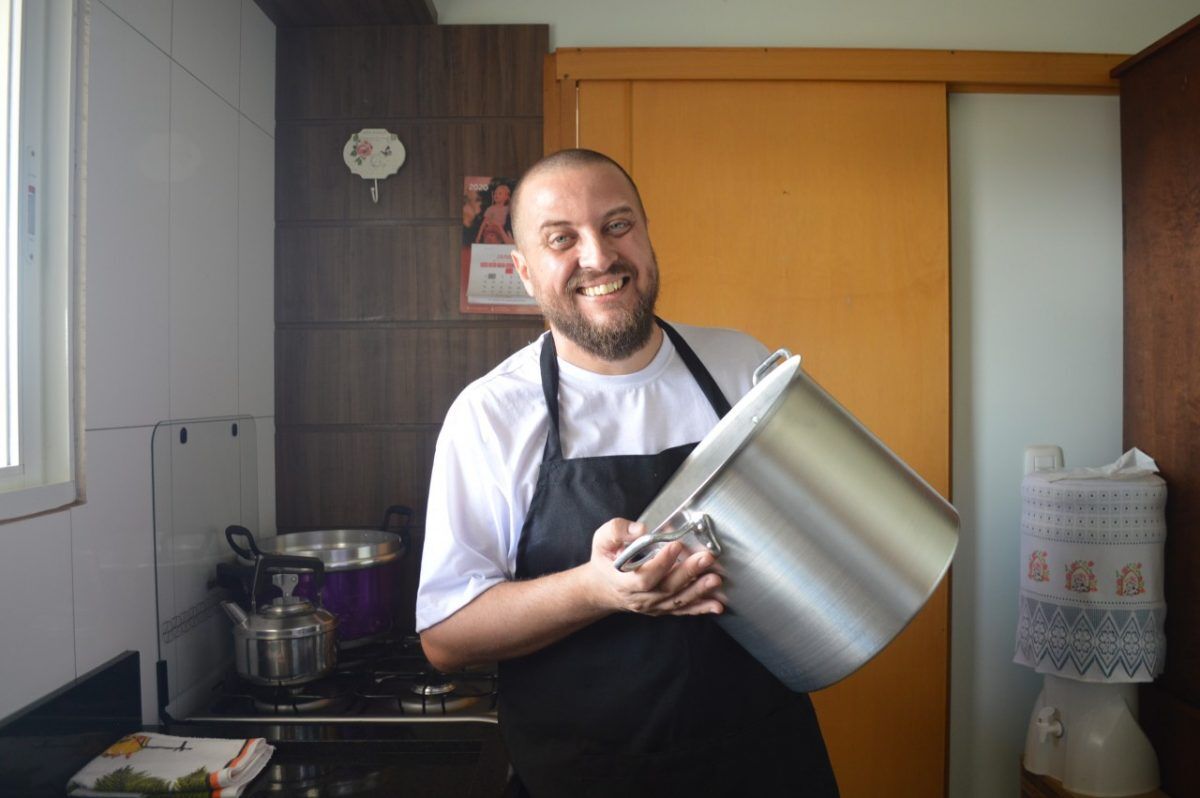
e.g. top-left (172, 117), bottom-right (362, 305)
top-left (418, 150), bottom-right (836, 798)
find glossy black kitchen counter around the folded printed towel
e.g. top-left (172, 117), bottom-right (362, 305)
top-left (0, 652), bottom-right (510, 798)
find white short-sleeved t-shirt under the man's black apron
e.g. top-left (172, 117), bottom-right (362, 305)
top-left (416, 324), bottom-right (768, 631)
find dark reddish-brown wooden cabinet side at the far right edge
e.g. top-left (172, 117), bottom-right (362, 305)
top-left (1116, 17), bottom-right (1200, 796)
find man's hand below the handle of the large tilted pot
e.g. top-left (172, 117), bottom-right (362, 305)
top-left (584, 518), bottom-right (725, 616)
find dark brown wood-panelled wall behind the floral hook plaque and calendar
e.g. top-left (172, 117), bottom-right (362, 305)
top-left (275, 25), bottom-right (548, 629)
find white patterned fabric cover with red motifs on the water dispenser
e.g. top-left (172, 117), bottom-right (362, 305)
top-left (1013, 452), bottom-right (1166, 682)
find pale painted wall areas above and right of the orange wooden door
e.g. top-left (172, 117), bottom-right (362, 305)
top-left (437, 0), bottom-right (1200, 798)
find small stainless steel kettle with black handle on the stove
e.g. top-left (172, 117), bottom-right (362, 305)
top-left (221, 554), bottom-right (337, 686)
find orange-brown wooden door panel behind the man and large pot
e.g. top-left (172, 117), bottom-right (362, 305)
top-left (576, 80), bottom-right (950, 798)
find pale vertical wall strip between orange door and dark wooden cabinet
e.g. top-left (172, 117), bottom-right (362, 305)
top-left (950, 95), bottom-right (1122, 798)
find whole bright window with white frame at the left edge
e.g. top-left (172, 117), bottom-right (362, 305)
top-left (0, 0), bottom-right (86, 521)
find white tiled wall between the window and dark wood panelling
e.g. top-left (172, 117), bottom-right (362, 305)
top-left (0, 0), bottom-right (275, 721)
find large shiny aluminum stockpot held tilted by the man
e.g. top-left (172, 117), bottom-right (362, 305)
top-left (616, 349), bottom-right (959, 691)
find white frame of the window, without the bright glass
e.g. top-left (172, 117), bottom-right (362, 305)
top-left (0, 0), bottom-right (90, 523)
